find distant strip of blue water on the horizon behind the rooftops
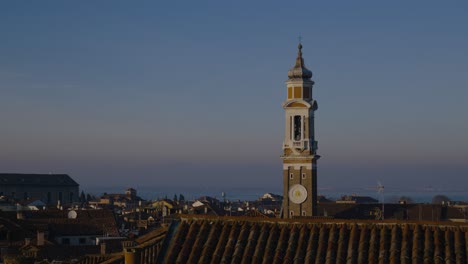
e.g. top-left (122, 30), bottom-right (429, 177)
top-left (84, 186), bottom-right (468, 203)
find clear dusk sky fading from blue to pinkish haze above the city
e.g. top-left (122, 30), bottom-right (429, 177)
top-left (0, 1), bottom-right (468, 193)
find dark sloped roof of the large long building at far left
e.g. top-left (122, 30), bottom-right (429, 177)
top-left (0, 173), bottom-right (79, 186)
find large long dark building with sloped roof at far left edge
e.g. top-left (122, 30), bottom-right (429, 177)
top-left (0, 173), bottom-right (79, 205)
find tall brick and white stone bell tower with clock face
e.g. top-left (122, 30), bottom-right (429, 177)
top-left (281, 44), bottom-right (320, 218)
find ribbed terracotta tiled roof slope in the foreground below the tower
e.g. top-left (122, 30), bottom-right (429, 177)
top-left (157, 217), bottom-right (468, 264)
